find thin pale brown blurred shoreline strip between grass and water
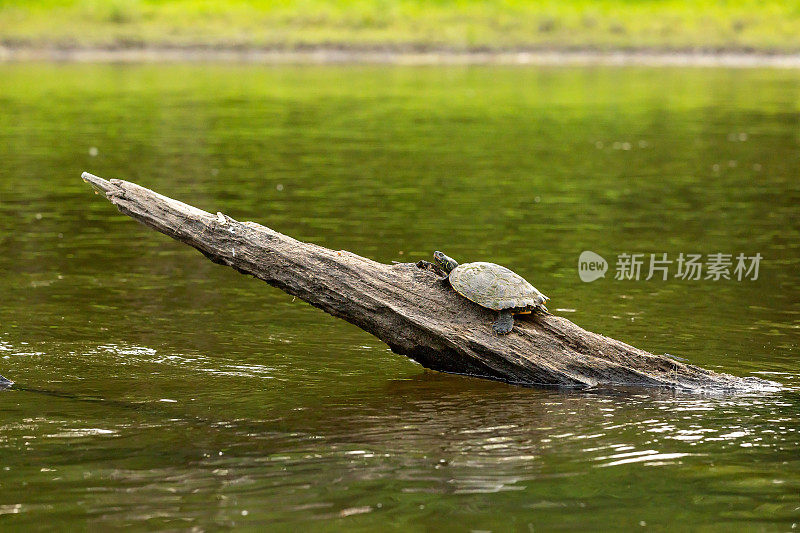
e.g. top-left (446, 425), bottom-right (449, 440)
top-left (0, 46), bottom-right (800, 69)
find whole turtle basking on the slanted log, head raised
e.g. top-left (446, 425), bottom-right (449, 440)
top-left (424, 250), bottom-right (550, 335)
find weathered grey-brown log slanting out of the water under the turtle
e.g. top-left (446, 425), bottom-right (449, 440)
top-left (82, 172), bottom-right (779, 392)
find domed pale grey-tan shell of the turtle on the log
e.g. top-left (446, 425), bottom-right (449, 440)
top-left (450, 262), bottom-right (549, 311)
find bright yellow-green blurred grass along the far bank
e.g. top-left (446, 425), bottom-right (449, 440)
top-left (0, 0), bottom-right (800, 51)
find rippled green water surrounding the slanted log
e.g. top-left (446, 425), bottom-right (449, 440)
top-left (0, 64), bottom-right (800, 532)
